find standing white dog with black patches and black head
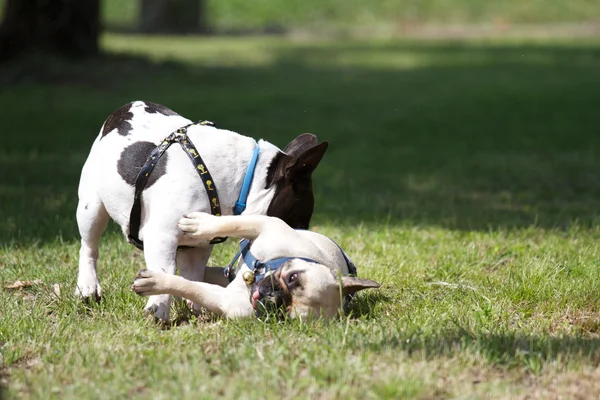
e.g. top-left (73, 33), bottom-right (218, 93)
top-left (76, 101), bottom-right (327, 321)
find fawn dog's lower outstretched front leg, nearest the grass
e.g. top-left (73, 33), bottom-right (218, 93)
top-left (131, 270), bottom-right (253, 318)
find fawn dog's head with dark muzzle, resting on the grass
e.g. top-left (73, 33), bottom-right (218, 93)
top-left (250, 258), bottom-right (380, 318)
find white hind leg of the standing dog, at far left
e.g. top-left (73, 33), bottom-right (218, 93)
top-left (75, 195), bottom-right (109, 300)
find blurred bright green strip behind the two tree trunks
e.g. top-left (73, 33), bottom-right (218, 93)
top-left (102, 0), bottom-right (600, 33)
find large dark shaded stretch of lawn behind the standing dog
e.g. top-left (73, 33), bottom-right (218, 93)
top-left (0, 42), bottom-right (600, 245)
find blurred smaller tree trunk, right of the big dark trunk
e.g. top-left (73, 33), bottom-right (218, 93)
top-left (141, 0), bottom-right (208, 34)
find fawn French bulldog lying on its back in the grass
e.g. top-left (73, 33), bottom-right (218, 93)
top-left (131, 212), bottom-right (379, 318)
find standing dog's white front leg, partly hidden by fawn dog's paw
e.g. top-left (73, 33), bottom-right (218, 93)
top-left (144, 226), bottom-right (178, 322)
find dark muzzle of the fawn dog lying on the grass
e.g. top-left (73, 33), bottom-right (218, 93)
top-left (250, 271), bottom-right (292, 319)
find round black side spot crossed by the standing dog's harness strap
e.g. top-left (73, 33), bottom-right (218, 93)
top-left (117, 142), bottom-right (168, 188)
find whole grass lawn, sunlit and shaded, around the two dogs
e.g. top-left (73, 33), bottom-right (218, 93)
top-left (0, 35), bottom-right (600, 399)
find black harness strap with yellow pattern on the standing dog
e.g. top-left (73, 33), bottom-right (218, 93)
top-left (128, 121), bottom-right (227, 250)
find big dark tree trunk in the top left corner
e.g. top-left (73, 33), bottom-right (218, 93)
top-left (0, 0), bottom-right (100, 61)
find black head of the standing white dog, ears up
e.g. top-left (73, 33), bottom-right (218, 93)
top-left (267, 133), bottom-right (328, 229)
